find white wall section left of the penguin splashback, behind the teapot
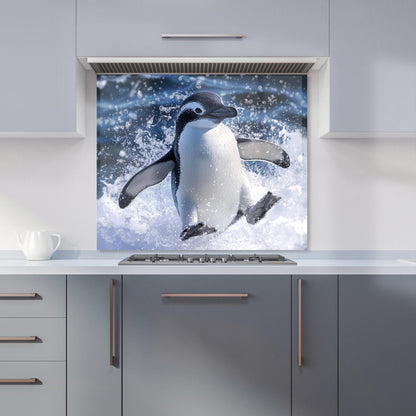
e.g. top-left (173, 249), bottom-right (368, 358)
top-left (0, 73), bottom-right (96, 250)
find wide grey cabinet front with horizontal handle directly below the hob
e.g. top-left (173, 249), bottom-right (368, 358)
top-left (123, 276), bottom-right (291, 416)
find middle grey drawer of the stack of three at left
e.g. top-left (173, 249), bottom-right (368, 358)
top-left (0, 318), bottom-right (66, 361)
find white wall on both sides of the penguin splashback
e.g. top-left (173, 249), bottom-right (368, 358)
top-left (0, 69), bottom-right (416, 250)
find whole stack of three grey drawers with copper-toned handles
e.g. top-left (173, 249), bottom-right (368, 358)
top-left (0, 275), bottom-right (66, 416)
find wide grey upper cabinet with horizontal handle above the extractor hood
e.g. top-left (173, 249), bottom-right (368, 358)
top-left (77, 0), bottom-right (329, 57)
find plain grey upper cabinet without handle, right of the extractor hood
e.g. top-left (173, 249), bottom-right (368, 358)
top-left (328, 0), bottom-right (416, 138)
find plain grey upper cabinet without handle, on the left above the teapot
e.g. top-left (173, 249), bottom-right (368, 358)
top-left (0, 0), bottom-right (82, 138)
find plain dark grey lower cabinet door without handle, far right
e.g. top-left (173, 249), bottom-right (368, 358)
top-left (339, 275), bottom-right (416, 416)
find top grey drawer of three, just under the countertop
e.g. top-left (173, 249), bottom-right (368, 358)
top-left (0, 275), bottom-right (66, 318)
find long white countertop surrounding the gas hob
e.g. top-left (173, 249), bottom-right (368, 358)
top-left (0, 255), bottom-right (416, 277)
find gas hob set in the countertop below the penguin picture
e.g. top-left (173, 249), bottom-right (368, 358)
top-left (119, 254), bottom-right (297, 266)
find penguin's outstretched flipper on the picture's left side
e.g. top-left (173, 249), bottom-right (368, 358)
top-left (118, 150), bottom-right (176, 208)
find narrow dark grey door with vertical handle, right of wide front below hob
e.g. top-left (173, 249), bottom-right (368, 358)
top-left (292, 276), bottom-right (338, 416)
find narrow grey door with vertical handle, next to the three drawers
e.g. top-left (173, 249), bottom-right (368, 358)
top-left (67, 275), bottom-right (121, 416)
